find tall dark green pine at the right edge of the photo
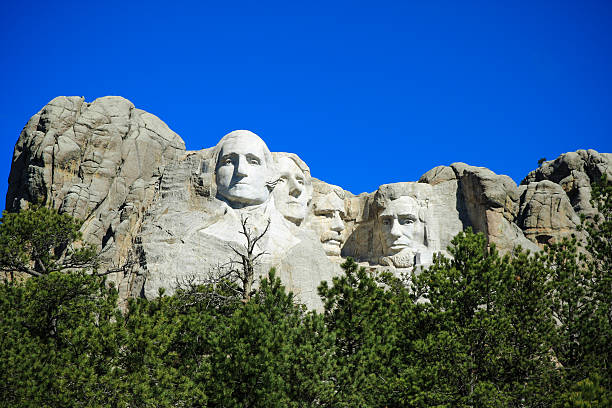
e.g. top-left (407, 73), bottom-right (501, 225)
top-left (546, 177), bottom-right (612, 390)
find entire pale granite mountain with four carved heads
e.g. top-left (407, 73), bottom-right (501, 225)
top-left (6, 96), bottom-right (612, 307)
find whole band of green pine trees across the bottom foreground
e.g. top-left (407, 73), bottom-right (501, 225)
top-left (0, 190), bottom-right (612, 408)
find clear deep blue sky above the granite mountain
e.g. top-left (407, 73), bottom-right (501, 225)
top-left (0, 0), bottom-right (612, 206)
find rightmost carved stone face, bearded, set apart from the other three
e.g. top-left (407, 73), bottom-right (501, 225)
top-left (378, 196), bottom-right (424, 255)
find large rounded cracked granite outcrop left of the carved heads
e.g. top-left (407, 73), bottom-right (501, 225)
top-left (6, 96), bottom-right (185, 297)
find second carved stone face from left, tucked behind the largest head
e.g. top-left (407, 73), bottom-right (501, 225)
top-left (273, 157), bottom-right (312, 225)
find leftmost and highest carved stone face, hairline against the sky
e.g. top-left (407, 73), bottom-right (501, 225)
top-left (216, 131), bottom-right (271, 208)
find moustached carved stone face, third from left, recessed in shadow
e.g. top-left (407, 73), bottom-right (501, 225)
top-left (310, 191), bottom-right (345, 256)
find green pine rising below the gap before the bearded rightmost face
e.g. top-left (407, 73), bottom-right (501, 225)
top-left (319, 258), bottom-right (401, 407)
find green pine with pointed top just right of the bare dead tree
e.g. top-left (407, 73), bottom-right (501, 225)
top-left (209, 271), bottom-right (332, 407)
